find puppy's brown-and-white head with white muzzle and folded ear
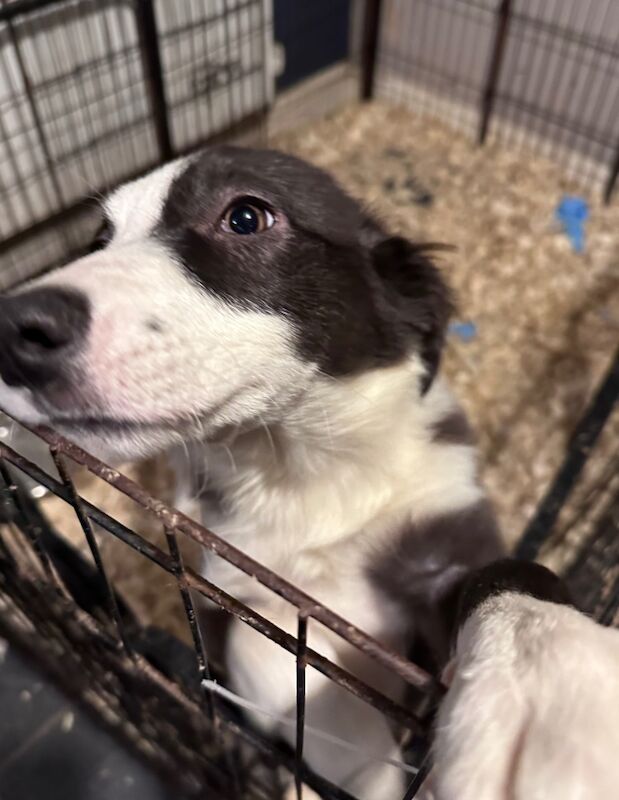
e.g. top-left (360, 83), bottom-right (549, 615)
top-left (0, 147), bottom-right (449, 460)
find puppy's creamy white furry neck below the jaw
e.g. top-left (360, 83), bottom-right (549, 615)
top-left (170, 361), bottom-right (474, 564)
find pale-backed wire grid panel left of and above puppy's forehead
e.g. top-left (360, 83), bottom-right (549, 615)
top-left (0, 0), bottom-right (274, 289)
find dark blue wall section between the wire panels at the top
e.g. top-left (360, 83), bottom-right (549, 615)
top-left (274, 0), bottom-right (351, 89)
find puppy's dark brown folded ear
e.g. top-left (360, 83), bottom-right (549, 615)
top-left (364, 228), bottom-right (453, 392)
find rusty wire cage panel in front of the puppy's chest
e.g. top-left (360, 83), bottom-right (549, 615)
top-left (0, 418), bottom-right (442, 800)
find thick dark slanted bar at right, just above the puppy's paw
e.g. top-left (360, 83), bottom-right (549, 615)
top-left (516, 350), bottom-right (619, 559)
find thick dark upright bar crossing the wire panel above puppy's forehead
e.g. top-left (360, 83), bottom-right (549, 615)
top-left (135, 0), bottom-right (174, 161)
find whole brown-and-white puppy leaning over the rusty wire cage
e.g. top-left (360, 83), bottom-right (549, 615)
top-left (0, 147), bottom-right (619, 800)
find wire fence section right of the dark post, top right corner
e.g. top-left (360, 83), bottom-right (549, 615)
top-left (494, 0), bottom-right (619, 195)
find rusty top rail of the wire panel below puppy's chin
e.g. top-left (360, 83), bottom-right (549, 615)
top-left (7, 418), bottom-right (440, 691)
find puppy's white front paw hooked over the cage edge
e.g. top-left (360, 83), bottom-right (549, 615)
top-left (432, 562), bottom-right (619, 800)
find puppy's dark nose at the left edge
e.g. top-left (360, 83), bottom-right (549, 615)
top-left (0, 288), bottom-right (90, 388)
